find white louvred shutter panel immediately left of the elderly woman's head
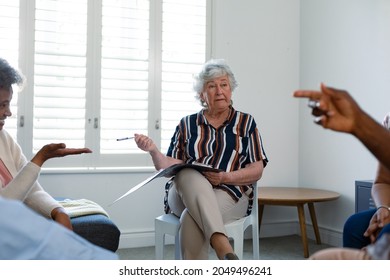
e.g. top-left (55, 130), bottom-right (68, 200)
top-left (161, 0), bottom-right (206, 151)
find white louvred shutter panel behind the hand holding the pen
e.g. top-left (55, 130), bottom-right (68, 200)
top-left (100, 0), bottom-right (150, 154)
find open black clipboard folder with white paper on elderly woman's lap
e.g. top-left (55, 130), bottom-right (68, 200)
top-left (109, 162), bottom-right (222, 206)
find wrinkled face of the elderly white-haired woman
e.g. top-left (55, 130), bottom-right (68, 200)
top-left (201, 75), bottom-right (232, 111)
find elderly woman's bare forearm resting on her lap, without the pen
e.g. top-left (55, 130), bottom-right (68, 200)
top-left (222, 161), bottom-right (264, 186)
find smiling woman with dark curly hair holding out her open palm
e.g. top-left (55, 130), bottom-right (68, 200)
top-left (0, 58), bottom-right (91, 229)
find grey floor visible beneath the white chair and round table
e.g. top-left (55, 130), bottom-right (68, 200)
top-left (117, 235), bottom-right (330, 260)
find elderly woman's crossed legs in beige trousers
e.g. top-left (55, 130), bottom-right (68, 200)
top-left (168, 169), bottom-right (248, 259)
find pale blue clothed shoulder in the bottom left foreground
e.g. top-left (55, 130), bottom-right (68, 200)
top-left (0, 197), bottom-right (118, 260)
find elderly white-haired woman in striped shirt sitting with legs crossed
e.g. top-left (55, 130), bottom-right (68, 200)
top-left (135, 60), bottom-right (268, 260)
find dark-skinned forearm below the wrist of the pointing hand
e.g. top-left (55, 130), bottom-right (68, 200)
top-left (352, 113), bottom-right (390, 169)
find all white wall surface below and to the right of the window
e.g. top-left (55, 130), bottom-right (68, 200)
top-left (40, 0), bottom-right (390, 247)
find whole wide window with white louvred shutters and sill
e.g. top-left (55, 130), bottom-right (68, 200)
top-left (0, 0), bottom-right (208, 168)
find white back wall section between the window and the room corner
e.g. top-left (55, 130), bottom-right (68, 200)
top-left (212, 0), bottom-right (299, 236)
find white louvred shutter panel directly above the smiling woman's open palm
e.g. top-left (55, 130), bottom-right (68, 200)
top-left (33, 0), bottom-right (87, 152)
